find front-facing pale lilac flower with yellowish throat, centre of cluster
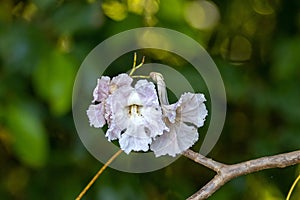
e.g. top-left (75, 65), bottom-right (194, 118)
top-left (106, 80), bottom-right (167, 153)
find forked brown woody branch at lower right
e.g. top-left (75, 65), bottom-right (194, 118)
top-left (183, 150), bottom-right (300, 200)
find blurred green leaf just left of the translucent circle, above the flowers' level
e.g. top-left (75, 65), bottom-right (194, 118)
top-left (33, 51), bottom-right (76, 115)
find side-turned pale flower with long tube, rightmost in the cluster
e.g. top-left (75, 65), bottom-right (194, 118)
top-left (150, 72), bottom-right (207, 157)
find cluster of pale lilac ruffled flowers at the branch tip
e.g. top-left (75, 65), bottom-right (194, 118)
top-left (87, 72), bottom-right (207, 157)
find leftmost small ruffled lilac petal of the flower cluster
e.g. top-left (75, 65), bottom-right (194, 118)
top-left (87, 103), bottom-right (106, 128)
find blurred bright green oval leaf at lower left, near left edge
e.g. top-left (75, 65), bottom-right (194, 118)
top-left (6, 102), bottom-right (49, 167)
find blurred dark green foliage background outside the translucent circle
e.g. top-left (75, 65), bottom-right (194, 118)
top-left (0, 0), bottom-right (300, 200)
